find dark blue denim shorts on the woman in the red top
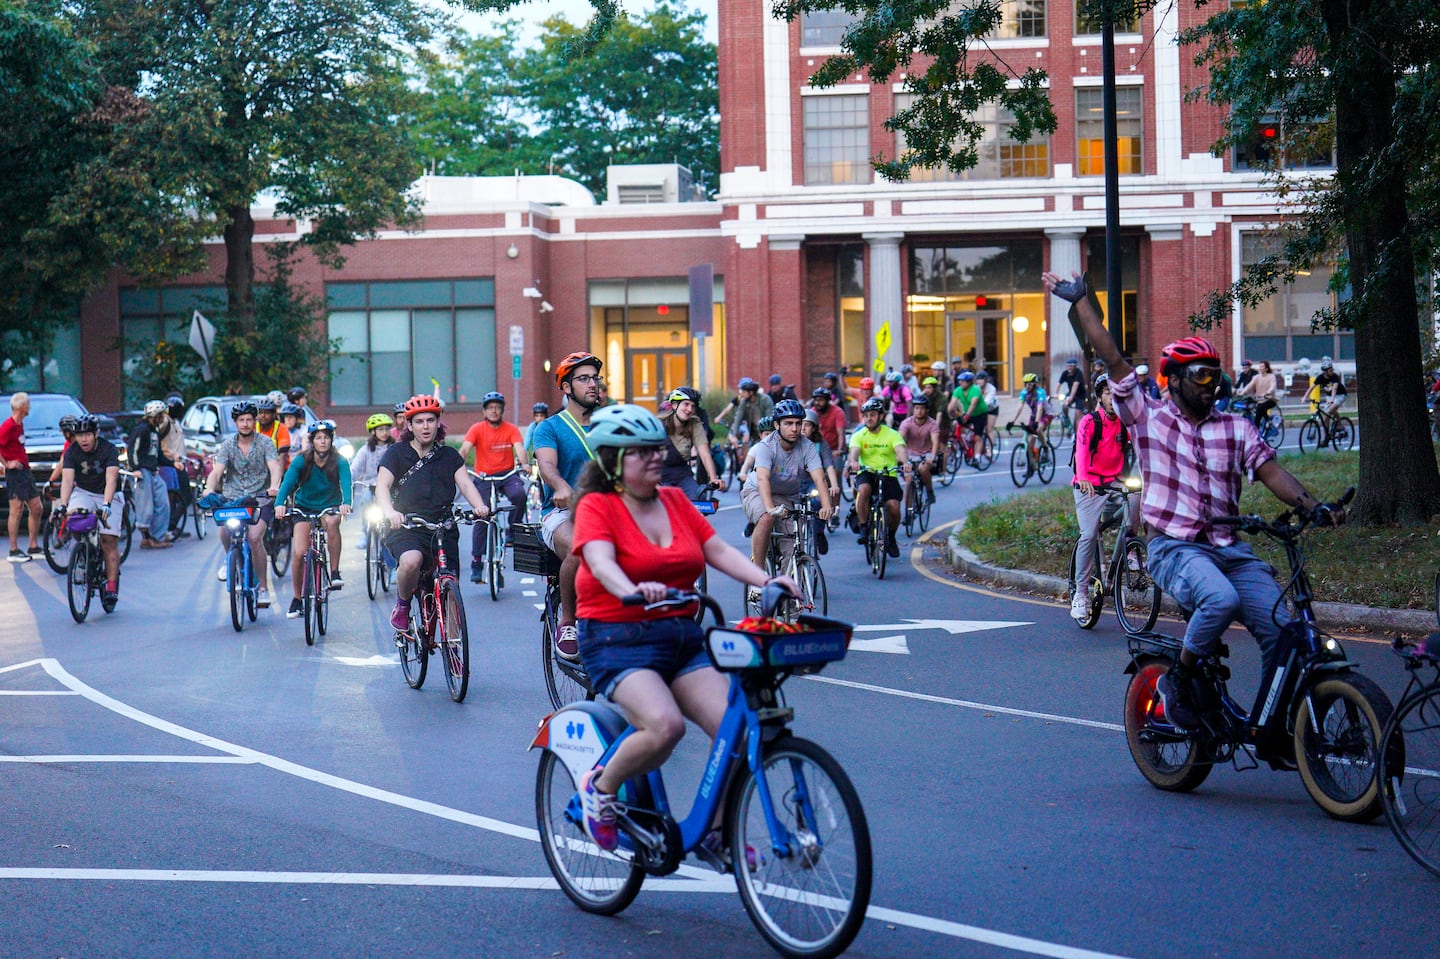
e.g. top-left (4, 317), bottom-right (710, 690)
top-left (577, 616), bottom-right (710, 698)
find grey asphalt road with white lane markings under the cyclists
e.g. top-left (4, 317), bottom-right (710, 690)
top-left (0, 434), bottom-right (1416, 959)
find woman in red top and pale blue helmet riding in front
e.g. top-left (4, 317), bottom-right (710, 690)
top-left (575, 400), bottom-right (799, 850)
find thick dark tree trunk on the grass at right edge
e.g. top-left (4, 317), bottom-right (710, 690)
top-left (1315, 0), bottom-right (1440, 524)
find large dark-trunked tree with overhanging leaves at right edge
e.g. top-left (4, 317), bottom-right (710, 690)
top-left (1182, 0), bottom-right (1440, 523)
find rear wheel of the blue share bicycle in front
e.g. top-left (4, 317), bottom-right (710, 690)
top-left (536, 752), bottom-right (645, 916)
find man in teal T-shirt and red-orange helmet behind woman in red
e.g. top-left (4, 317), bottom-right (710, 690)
top-left (530, 350), bottom-right (607, 662)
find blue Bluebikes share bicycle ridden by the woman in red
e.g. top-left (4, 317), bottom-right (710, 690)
top-left (530, 586), bottom-right (871, 959)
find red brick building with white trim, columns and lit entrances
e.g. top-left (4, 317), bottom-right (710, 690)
top-left (12, 0), bottom-right (1354, 432)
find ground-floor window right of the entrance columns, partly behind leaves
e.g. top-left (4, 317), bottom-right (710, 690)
top-left (1240, 232), bottom-right (1355, 361)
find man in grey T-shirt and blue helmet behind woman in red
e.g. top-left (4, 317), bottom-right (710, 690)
top-left (740, 399), bottom-right (834, 581)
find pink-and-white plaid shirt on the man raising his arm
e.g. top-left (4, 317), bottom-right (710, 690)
top-left (1115, 373), bottom-right (1274, 546)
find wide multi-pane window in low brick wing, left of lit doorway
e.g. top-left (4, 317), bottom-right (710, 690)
top-left (325, 279), bottom-right (495, 406)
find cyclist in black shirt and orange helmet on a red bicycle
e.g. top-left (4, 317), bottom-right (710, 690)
top-left (374, 396), bottom-right (490, 631)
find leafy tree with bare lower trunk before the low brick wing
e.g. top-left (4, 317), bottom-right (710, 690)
top-left (66, 0), bottom-right (449, 337)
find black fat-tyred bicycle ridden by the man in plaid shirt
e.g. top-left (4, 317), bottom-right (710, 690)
top-left (1125, 488), bottom-right (1403, 822)
